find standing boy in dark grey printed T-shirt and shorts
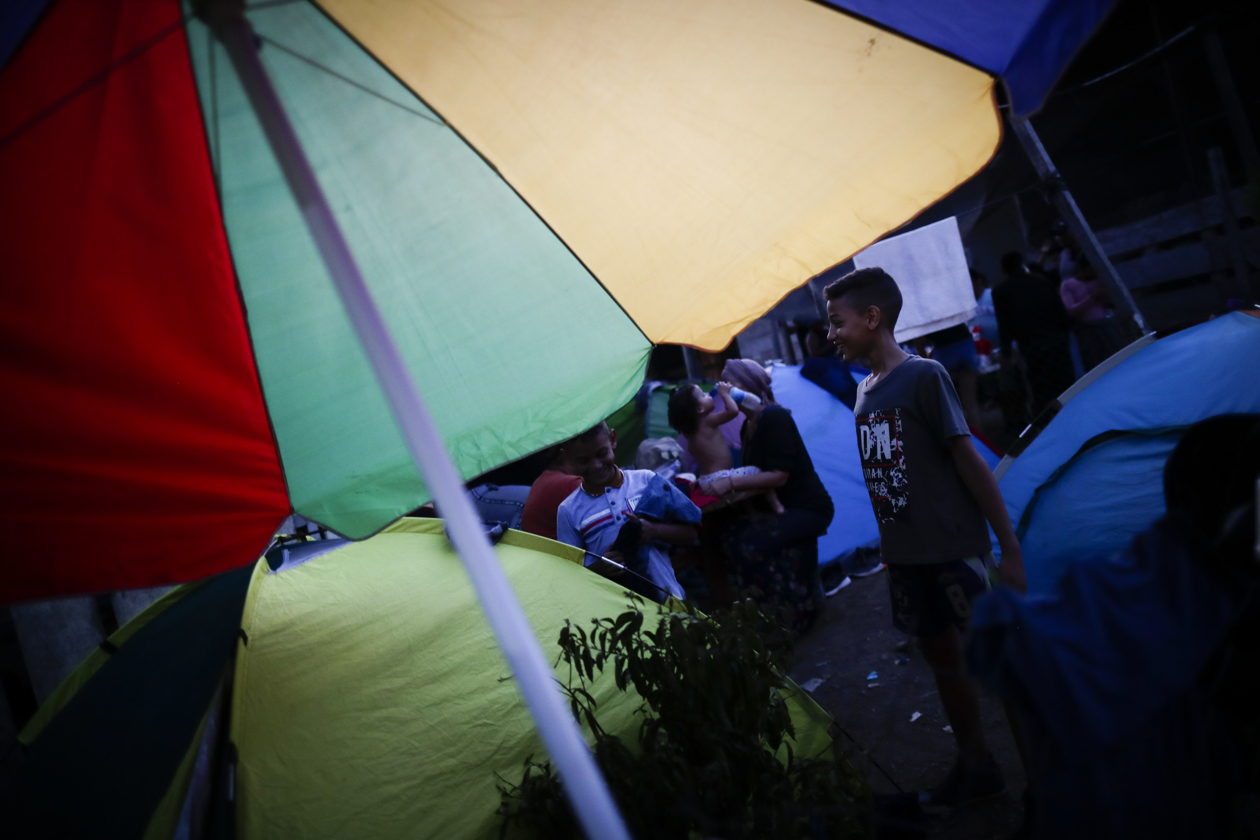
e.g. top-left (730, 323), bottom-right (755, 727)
top-left (824, 268), bottom-right (1024, 807)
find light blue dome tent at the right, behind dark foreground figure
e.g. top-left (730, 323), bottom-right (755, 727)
top-left (997, 312), bottom-right (1260, 594)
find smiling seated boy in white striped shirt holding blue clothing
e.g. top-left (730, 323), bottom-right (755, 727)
top-left (556, 423), bottom-right (701, 602)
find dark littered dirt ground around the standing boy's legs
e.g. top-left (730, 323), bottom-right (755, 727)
top-left (791, 572), bottom-right (1024, 840)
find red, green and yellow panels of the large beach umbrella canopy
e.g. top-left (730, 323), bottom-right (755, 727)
top-left (0, 0), bottom-right (1097, 602)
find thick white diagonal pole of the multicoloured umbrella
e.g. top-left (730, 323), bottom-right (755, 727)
top-left (198, 6), bottom-right (630, 840)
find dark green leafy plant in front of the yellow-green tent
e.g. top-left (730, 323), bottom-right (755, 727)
top-left (498, 598), bottom-right (873, 840)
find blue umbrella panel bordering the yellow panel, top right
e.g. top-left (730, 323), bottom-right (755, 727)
top-left (825, 0), bottom-right (1115, 116)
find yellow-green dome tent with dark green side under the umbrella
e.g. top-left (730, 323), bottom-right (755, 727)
top-left (10, 519), bottom-right (830, 837)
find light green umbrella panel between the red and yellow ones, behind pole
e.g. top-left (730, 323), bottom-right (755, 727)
top-left (186, 3), bottom-right (650, 538)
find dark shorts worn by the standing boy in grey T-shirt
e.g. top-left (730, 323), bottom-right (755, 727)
top-left (888, 553), bottom-right (998, 639)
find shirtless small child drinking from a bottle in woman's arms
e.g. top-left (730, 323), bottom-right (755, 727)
top-left (669, 382), bottom-right (784, 514)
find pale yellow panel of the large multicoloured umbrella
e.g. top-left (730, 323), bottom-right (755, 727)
top-left (321, 0), bottom-right (1000, 350)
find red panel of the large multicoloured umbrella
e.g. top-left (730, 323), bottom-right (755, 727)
top-left (0, 3), bottom-right (291, 601)
